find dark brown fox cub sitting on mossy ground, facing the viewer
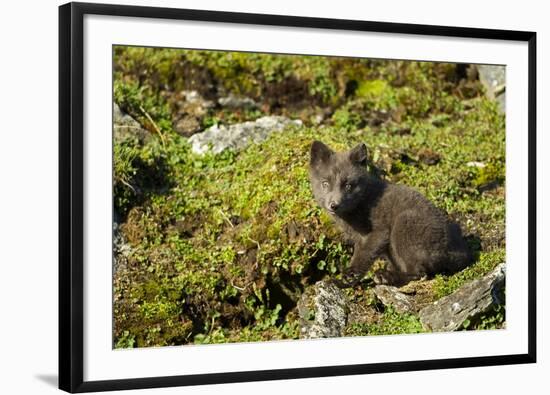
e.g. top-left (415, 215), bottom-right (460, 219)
top-left (309, 141), bottom-right (472, 287)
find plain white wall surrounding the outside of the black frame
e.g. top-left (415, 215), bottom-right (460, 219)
top-left (0, 0), bottom-right (550, 394)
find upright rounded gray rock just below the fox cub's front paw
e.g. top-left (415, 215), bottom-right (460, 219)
top-left (298, 281), bottom-right (349, 339)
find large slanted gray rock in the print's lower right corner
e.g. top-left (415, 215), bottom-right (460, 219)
top-left (419, 263), bottom-right (506, 332)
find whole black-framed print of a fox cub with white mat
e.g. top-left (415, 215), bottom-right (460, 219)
top-left (59, 3), bottom-right (536, 392)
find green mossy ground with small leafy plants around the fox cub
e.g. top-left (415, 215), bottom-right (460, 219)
top-left (114, 47), bottom-right (505, 347)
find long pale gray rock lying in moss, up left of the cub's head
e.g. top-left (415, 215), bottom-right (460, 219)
top-left (189, 116), bottom-right (302, 155)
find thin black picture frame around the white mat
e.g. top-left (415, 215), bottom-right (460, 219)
top-left (59, 3), bottom-right (536, 393)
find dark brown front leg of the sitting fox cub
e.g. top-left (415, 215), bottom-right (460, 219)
top-left (337, 232), bottom-right (389, 288)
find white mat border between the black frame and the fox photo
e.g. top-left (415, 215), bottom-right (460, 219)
top-left (84, 16), bottom-right (528, 381)
